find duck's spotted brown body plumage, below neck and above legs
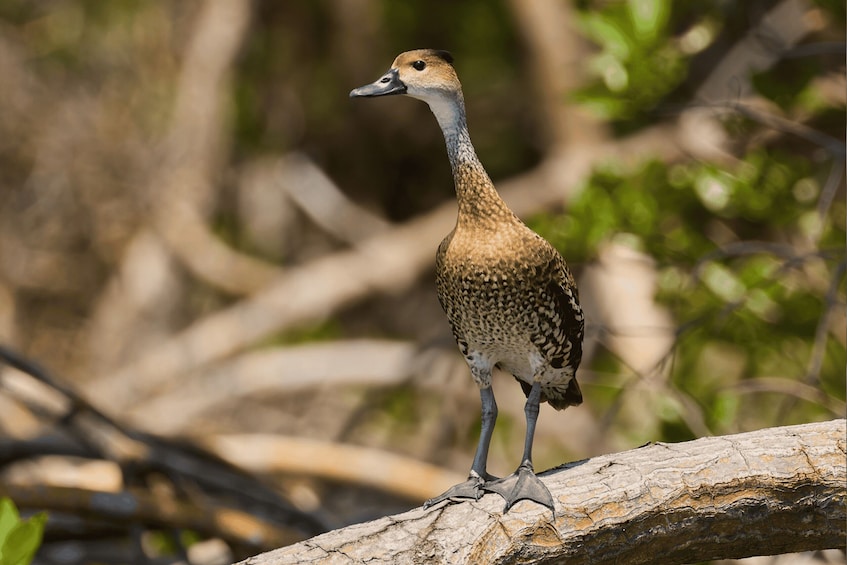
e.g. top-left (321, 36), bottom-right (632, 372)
top-left (436, 178), bottom-right (583, 410)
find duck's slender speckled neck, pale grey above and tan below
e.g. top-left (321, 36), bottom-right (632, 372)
top-left (429, 94), bottom-right (514, 225)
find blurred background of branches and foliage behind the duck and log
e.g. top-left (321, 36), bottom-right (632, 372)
top-left (0, 0), bottom-right (847, 564)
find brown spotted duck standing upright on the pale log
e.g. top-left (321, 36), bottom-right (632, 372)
top-left (350, 49), bottom-right (585, 516)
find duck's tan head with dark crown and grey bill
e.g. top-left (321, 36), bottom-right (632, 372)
top-left (350, 49), bottom-right (462, 102)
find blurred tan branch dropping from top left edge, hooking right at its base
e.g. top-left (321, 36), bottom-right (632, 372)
top-left (150, 0), bottom-right (280, 294)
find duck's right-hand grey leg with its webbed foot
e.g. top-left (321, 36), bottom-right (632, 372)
top-left (483, 382), bottom-right (556, 516)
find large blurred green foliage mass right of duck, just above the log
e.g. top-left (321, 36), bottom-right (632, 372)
top-left (534, 149), bottom-right (845, 435)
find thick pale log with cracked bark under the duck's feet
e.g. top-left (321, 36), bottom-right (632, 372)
top-left (237, 420), bottom-right (847, 565)
